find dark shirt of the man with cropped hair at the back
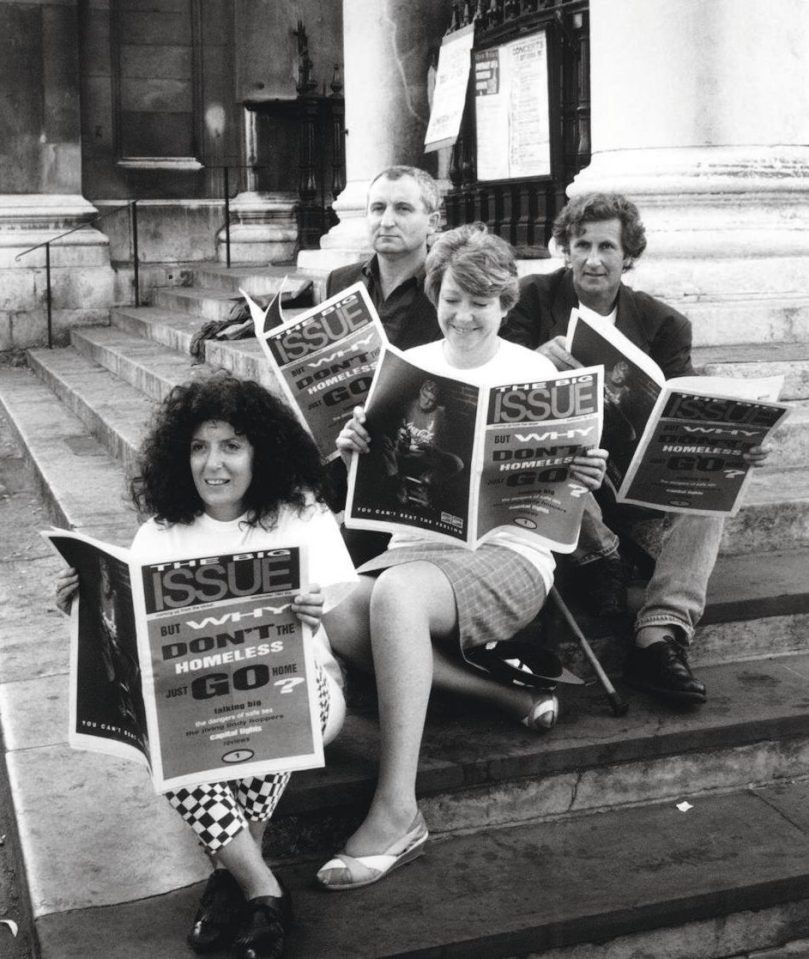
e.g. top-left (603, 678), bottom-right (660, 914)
top-left (326, 254), bottom-right (442, 350)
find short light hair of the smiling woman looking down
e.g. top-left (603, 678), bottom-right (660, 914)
top-left (424, 223), bottom-right (520, 310)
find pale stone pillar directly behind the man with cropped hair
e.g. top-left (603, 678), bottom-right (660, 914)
top-left (298, 0), bottom-right (452, 270)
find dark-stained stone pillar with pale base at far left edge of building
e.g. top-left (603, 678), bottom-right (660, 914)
top-left (0, 0), bottom-right (113, 351)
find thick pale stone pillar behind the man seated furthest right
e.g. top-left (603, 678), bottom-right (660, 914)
top-left (569, 0), bottom-right (809, 296)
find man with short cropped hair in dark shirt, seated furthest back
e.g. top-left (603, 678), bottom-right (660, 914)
top-left (326, 166), bottom-right (442, 565)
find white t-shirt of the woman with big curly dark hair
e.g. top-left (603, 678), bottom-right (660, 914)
top-left (131, 497), bottom-right (358, 686)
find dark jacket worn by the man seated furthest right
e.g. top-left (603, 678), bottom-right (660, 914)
top-left (500, 268), bottom-right (694, 379)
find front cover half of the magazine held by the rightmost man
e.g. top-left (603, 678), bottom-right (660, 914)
top-left (618, 376), bottom-right (787, 516)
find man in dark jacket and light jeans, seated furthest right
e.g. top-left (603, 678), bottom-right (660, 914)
top-left (501, 193), bottom-right (769, 703)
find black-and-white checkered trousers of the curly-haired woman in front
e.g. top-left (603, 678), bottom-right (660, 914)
top-left (166, 666), bottom-right (331, 852)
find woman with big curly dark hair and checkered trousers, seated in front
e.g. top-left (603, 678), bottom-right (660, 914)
top-left (57, 376), bottom-right (356, 959)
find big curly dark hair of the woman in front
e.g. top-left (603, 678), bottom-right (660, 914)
top-left (130, 375), bottom-right (324, 528)
